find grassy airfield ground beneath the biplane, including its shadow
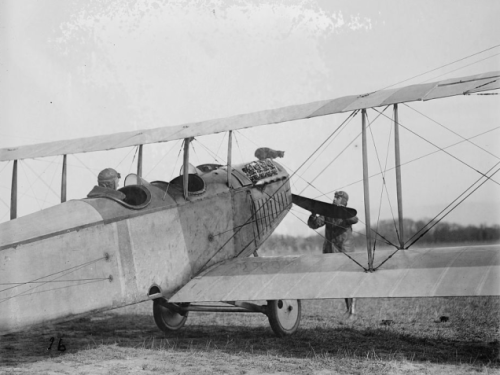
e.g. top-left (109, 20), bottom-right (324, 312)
top-left (0, 297), bottom-right (500, 374)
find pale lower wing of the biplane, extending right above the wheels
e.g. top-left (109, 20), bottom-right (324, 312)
top-left (169, 245), bottom-right (500, 303)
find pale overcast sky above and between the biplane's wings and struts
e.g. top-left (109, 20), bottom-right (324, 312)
top-left (0, 0), bottom-right (500, 235)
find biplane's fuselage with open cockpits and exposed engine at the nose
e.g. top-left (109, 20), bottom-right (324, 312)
top-left (0, 160), bottom-right (292, 333)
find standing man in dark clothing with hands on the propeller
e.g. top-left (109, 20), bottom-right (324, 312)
top-left (307, 191), bottom-right (358, 316)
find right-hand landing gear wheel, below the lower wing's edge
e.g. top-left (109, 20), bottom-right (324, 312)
top-left (267, 299), bottom-right (302, 337)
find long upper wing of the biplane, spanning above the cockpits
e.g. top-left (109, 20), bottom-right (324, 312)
top-left (0, 71), bottom-right (500, 161)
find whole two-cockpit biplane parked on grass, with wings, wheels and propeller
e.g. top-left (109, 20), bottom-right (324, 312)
top-left (0, 71), bottom-right (500, 336)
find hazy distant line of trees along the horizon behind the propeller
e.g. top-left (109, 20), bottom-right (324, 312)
top-left (261, 219), bottom-right (500, 253)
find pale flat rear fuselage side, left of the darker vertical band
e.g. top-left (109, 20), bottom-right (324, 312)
top-left (0, 219), bottom-right (123, 333)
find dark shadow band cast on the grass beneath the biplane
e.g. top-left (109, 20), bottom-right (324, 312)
top-left (0, 314), bottom-right (500, 367)
